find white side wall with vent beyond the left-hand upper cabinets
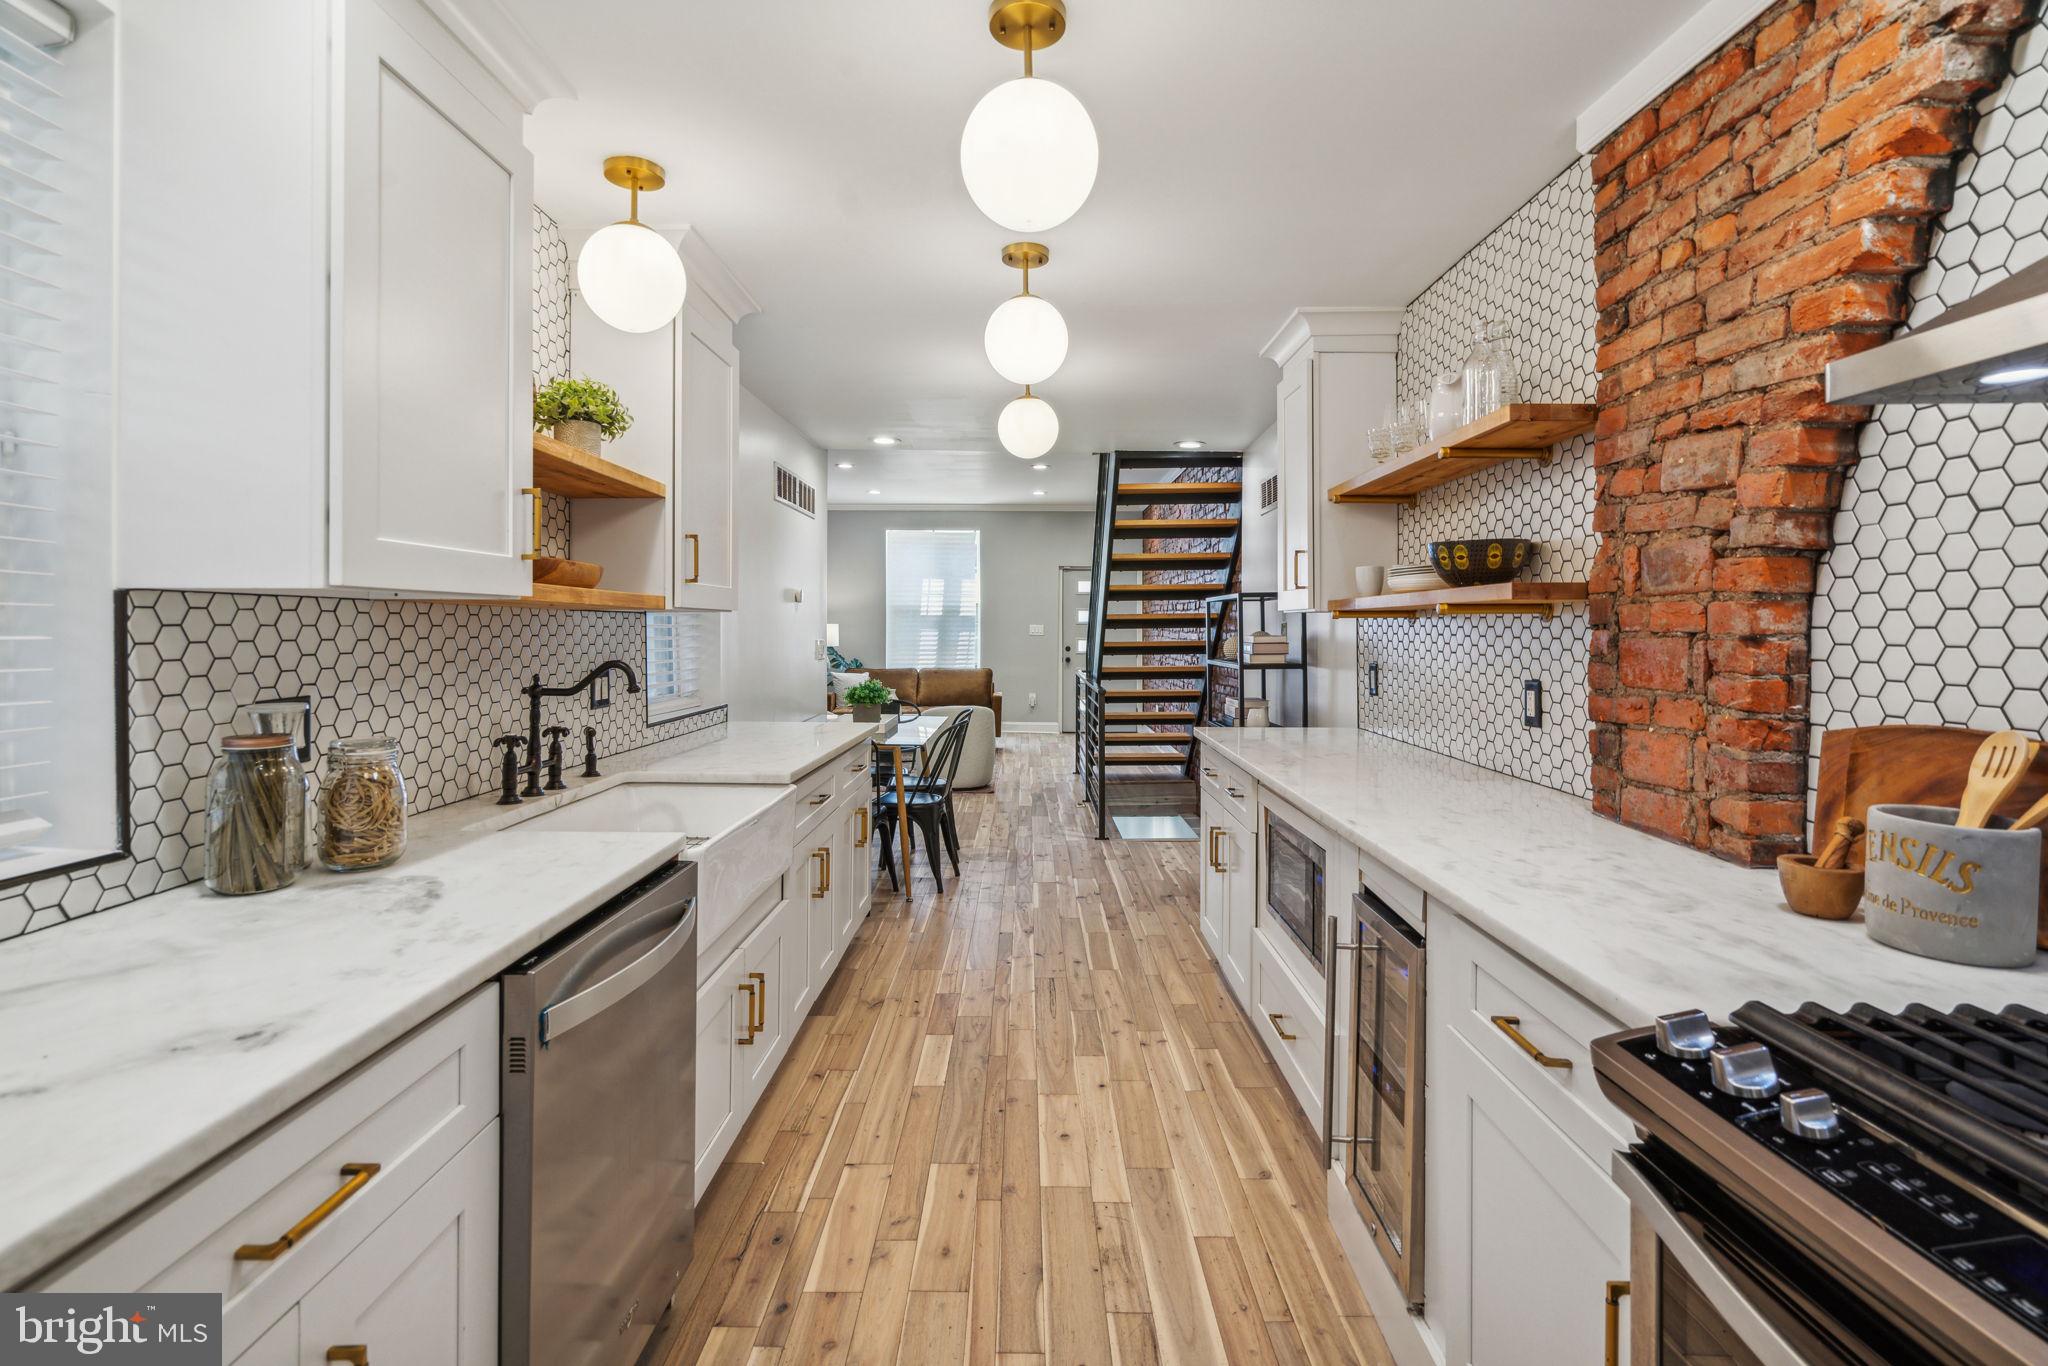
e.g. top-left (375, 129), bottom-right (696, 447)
top-left (723, 387), bottom-right (825, 721)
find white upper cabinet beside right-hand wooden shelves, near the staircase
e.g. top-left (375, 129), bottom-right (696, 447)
top-left (1262, 309), bottom-right (1401, 612)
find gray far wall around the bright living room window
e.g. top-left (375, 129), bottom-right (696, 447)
top-left (825, 508), bottom-right (1096, 731)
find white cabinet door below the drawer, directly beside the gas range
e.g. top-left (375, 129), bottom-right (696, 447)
top-left (1425, 1028), bottom-right (1628, 1366)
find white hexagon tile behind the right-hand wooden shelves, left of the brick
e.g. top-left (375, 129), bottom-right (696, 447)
top-left (1358, 160), bottom-right (1599, 797)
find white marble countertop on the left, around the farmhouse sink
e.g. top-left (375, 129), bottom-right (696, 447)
top-left (0, 721), bottom-right (874, 1288)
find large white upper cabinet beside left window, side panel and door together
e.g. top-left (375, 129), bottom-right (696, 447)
top-left (115, 0), bottom-right (561, 598)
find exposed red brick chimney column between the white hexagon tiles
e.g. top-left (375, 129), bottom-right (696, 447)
top-left (1589, 0), bottom-right (2032, 864)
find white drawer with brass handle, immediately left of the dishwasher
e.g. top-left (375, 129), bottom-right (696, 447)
top-left (37, 983), bottom-right (500, 1360)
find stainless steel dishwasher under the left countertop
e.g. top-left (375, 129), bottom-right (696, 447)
top-left (498, 862), bottom-right (696, 1366)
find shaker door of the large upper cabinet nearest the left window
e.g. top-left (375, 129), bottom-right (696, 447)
top-left (328, 0), bottom-right (535, 596)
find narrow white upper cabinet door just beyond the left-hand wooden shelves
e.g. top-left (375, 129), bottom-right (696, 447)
top-left (670, 305), bottom-right (739, 612)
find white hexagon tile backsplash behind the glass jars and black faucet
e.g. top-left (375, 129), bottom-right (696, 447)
top-left (0, 590), bottom-right (725, 940)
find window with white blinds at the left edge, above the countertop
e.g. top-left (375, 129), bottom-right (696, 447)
top-left (0, 0), bottom-right (123, 883)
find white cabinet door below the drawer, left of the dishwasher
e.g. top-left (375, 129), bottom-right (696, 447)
top-left (299, 1120), bottom-right (498, 1366)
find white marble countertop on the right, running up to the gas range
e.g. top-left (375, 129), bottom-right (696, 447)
top-left (1200, 727), bottom-right (2048, 1024)
